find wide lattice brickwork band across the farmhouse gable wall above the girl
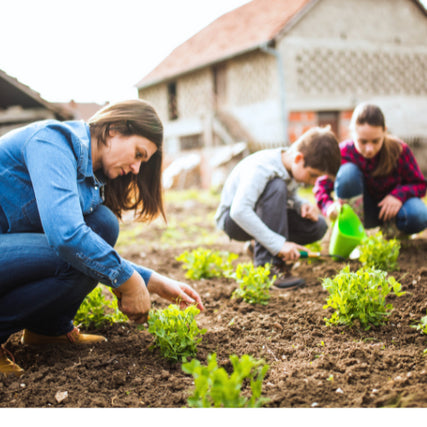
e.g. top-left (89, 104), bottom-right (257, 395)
top-left (296, 47), bottom-right (427, 95)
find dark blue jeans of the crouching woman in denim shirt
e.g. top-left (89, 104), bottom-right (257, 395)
top-left (0, 205), bottom-right (119, 344)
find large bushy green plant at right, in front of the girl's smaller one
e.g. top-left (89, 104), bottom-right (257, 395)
top-left (322, 265), bottom-right (405, 329)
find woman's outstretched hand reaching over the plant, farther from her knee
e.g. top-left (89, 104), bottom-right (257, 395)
top-left (147, 272), bottom-right (205, 311)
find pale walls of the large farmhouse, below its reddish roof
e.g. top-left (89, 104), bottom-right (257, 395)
top-left (140, 0), bottom-right (427, 153)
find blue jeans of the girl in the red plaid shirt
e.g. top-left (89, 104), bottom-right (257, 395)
top-left (335, 163), bottom-right (427, 234)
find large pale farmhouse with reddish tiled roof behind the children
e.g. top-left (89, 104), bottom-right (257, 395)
top-left (137, 0), bottom-right (427, 186)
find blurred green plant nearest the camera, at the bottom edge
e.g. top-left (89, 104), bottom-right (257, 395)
top-left (182, 353), bottom-right (269, 408)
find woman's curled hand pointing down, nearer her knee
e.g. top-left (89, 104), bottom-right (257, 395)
top-left (113, 271), bottom-right (151, 323)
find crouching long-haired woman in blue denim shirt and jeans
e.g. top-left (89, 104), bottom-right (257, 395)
top-left (0, 100), bottom-right (203, 375)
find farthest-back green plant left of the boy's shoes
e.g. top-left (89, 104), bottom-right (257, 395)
top-left (176, 248), bottom-right (238, 280)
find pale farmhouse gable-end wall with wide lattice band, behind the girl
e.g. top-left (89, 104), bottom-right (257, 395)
top-left (279, 0), bottom-right (427, 136)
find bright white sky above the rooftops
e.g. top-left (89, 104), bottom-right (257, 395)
top-left (0, 0), bottom-right (249, 103)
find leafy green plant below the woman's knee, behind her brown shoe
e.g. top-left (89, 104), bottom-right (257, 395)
top-left (74, 285), bottom-right (128, 329)
